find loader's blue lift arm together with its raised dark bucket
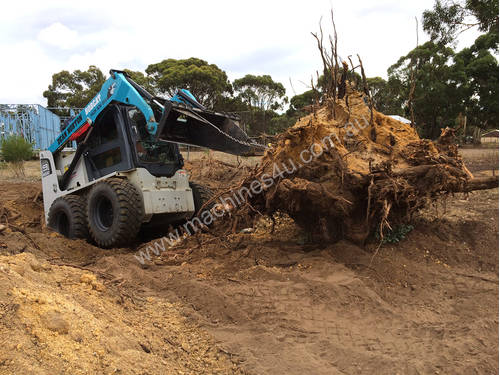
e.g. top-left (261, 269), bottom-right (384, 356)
top-left (49, 70), bottom-right (265, 190)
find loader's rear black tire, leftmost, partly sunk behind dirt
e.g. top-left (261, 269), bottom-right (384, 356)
top-left (49, 194), bottom-right (88, 238)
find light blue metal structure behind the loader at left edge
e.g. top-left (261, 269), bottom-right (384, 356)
top-left (0, 104), bottom-right (61, 150)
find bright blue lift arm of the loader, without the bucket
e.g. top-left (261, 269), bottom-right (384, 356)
top-left (48, 70), bottom-right (158, 153)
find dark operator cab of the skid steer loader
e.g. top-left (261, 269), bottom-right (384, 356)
top-left (85, 104), bottom-right (184, 179)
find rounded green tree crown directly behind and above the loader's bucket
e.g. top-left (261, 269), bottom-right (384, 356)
top-left (146, 57), bottom-right (232, 109)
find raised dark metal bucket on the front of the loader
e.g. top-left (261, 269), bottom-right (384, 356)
top-left (156, 102), bottom-right (266, 156)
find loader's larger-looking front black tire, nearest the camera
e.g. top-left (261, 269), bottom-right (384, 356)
top-left (87, 178), bottom-right (144, 248)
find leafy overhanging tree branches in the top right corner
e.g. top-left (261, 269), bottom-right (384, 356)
top-left (422, 0), bottom-right (498, 49)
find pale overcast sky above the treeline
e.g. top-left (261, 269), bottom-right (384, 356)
top-left (0, 0), bottom-right (475, 105)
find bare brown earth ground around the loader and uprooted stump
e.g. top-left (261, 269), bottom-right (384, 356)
top-left (0, 150), bottom-right (498, 374)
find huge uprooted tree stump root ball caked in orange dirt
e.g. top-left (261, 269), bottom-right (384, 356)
top-left (237, 91), bottom-right (488, 243)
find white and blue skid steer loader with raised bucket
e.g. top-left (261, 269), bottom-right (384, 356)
top-left (40, 70), bottom-right (263, 248)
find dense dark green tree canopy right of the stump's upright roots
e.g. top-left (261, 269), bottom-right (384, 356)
top-left (386, 34), bottom-right (498, 138)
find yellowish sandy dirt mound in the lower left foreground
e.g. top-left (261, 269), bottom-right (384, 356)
top-left (0, 253), bottom-right (240, 374)
